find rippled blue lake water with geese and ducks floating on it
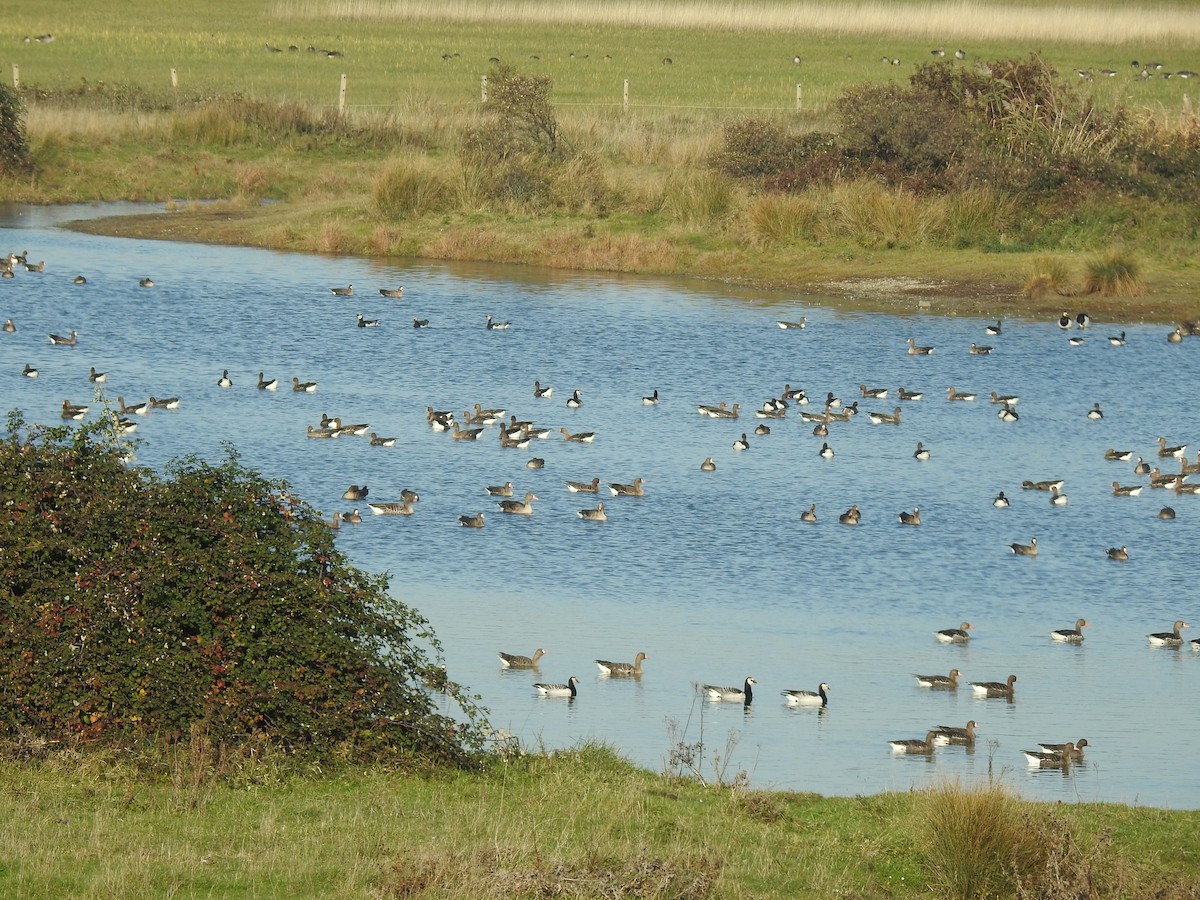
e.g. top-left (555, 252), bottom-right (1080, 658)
top-left (0, 205), bottom-right (1200, 809)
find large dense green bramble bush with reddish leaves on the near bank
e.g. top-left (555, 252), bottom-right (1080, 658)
top-left (0, 414), bottom-right (481, 764)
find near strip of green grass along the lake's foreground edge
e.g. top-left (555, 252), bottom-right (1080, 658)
top-left (0, 746), bottom-right (1200, 899)
